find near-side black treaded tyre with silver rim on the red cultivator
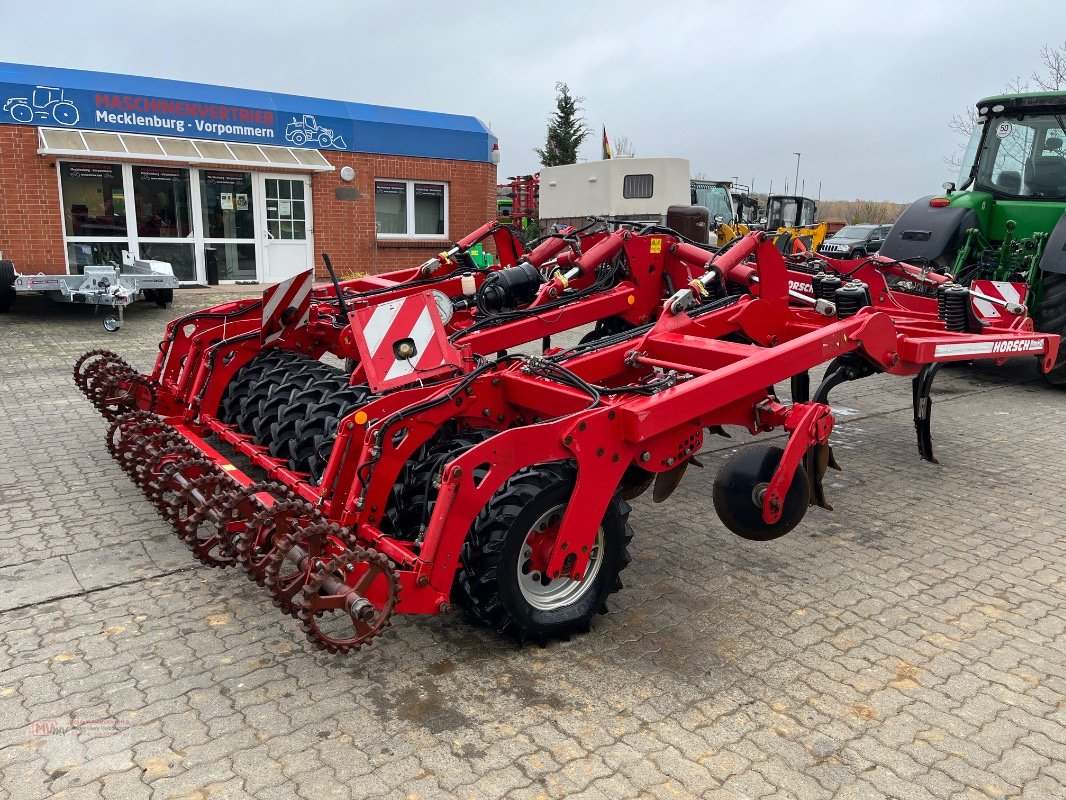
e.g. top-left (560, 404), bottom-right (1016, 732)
top-left (453, 464), bottom-right (633, 642)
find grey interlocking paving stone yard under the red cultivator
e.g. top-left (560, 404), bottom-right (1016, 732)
top-left (0, 292), bottom-right (1066, 800)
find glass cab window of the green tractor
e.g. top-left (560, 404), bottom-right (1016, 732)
top-left (975, 114), bottom-right (1066, 197)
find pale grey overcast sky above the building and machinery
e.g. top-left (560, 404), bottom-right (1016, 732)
top-left (0, 0), bottom-right (1066, 202)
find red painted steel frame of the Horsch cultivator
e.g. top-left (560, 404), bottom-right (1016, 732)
top-left (89, 231), bottom-right (1059, 613)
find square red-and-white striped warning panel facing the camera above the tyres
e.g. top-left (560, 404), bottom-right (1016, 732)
top-left (349, 291), bottom-right (462, 391)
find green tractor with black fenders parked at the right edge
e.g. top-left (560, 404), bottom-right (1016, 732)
top-left (881, 92), bottom-right (1066, 388)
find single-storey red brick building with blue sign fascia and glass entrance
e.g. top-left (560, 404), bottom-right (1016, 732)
top-left (0, 63), bottom-right (496, 284)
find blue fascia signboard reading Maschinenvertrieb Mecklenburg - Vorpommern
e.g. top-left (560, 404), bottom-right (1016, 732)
top-left (0, 63), bottom-right (496, 161)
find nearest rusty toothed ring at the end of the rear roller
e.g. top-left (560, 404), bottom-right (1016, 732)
top-left (296, 546), bottom-right (400, 653)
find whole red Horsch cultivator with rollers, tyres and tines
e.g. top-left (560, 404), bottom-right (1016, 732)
top-left (75, 217), bottom-right (1059, 652)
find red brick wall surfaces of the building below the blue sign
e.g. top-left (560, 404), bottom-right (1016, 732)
top-left (0, 125), bottom-right (496, 277)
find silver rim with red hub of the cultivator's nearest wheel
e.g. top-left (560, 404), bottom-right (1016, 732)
top-left (516, 503), bottom-right (603, 611)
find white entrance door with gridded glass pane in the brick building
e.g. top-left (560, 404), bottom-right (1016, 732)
top-left (258, 173), bottom-right (314, 283)
